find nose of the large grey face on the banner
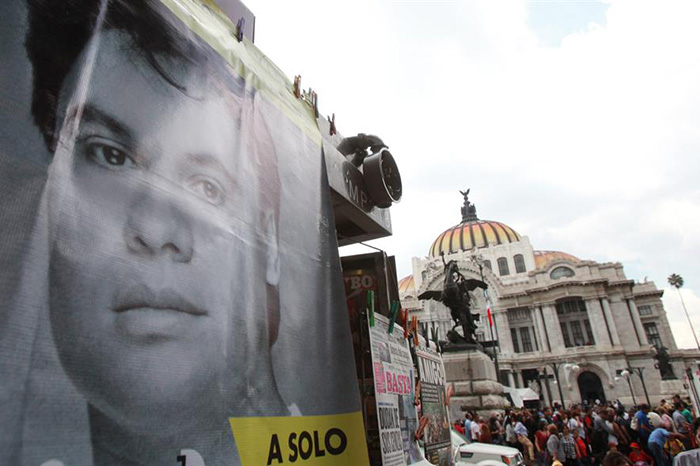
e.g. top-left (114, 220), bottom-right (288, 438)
top-left (124, 182), bottom-right (194, 262)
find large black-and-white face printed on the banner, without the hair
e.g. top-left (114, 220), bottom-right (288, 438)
top-left (50, 31), bottom-right (269, 430)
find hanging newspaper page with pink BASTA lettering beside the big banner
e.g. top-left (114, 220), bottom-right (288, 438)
top-left (368, 314), bottom-right (422, 466)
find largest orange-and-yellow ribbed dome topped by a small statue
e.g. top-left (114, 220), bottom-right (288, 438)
top-left (430, 219), bottom-right (520, 257)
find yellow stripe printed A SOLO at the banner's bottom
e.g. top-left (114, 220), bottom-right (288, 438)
top-left (229, 411), bottom-right (369, 466)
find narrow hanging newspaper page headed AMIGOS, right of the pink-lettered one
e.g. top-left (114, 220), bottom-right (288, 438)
top-left (416, 346), bottom-right (452, 466)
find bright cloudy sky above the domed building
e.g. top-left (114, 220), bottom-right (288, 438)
top-left (244, 0), bottom-right (700, 348)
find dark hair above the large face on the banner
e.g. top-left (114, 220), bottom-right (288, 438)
top-left (25, 0), bottom-right (223, 150)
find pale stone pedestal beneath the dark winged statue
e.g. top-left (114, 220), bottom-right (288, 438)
top-left (442, 350), bottom-right (508, 420)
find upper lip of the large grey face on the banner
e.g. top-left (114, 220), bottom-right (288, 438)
top-left (112, 285), bottom-right (209, 317)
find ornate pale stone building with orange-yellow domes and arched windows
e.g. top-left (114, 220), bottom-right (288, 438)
top-left (399, 191), bottom-right (698, 406)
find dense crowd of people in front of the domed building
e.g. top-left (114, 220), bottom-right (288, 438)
top-left (455, 395), bottom-right (700, 466)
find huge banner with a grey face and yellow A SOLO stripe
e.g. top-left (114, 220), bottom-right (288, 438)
top-left (0, 0), bottom-right (367, 466)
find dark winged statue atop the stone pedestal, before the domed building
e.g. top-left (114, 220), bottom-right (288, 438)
top-left (418, 255), bottom-right (488, 345)
